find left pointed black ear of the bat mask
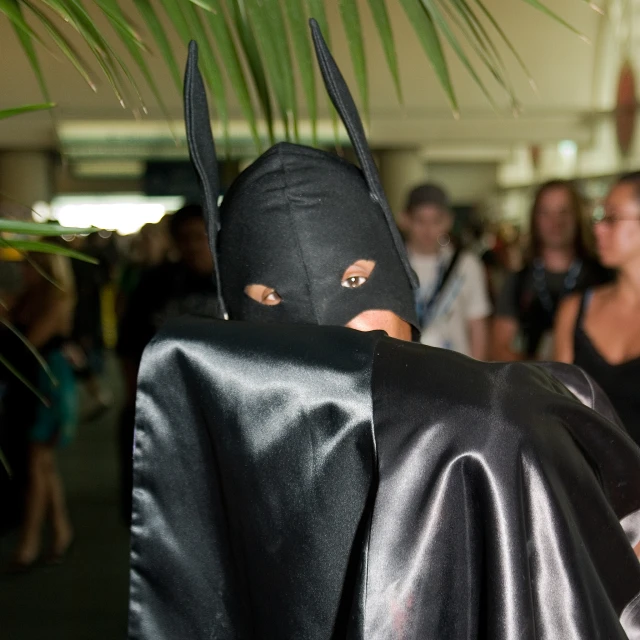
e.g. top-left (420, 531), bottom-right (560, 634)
top-left (184, 40), bottom-right (227, 318)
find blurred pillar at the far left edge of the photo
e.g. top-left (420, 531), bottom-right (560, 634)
top-left (0, 151), bottom-right (53, 219)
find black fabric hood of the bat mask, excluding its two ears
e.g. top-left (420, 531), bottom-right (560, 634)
top-left (218, 143), bottom-right (415, 325)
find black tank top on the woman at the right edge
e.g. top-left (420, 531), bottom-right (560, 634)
top-left (573, 290), bottom-right (640, 444)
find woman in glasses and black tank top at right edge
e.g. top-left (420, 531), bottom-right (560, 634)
top-left (555, 172), bottom-right (640, 443)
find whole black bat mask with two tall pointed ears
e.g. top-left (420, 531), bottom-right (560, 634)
top-left (185, 20), bottom-right (418, 330)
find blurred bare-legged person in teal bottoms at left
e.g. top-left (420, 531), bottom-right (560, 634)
top-left (7, 254), bottom-right (77, 570)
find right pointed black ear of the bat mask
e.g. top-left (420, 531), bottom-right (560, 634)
top-left (309, 18), bottom-right (418, 289)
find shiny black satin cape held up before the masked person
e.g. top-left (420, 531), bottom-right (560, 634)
top-left (129, 319), bottom-right (640, 640)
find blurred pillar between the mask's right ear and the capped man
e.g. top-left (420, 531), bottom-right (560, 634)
top-left (376, 149), bottom-right (427, 215)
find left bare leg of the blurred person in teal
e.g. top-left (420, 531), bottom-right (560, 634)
top-left (14, 444), bottom-right (49, 565)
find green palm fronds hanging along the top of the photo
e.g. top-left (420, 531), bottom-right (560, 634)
top-left (0, 0), bottom-right (596, 149)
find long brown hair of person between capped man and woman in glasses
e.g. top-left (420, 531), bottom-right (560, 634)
top-left (528, 180), bottom-right (594, 260)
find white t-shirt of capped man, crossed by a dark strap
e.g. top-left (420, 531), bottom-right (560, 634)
top-left (409, 247), bottom-right (491, 355)
